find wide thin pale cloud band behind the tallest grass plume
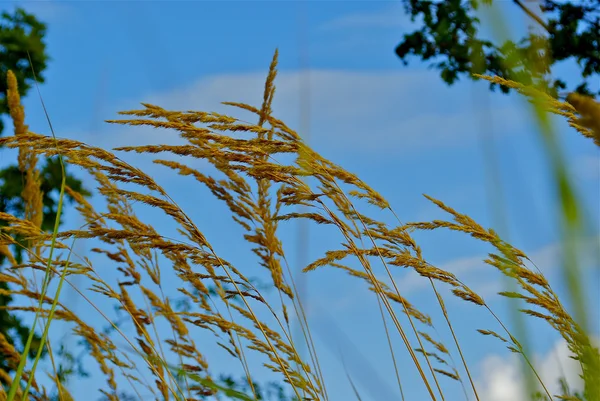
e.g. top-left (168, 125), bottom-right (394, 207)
top-left (119, 70), bottom-right (527, 155)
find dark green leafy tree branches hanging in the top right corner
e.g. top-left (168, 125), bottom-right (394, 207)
top-left (396, 0), bottom-right (600, 96)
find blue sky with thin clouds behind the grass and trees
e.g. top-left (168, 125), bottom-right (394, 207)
top-left (0, 1), bottom-right (600, 401)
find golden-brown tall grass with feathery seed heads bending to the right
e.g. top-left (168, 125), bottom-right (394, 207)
top-left (0, 52), bottom-right (600, 401)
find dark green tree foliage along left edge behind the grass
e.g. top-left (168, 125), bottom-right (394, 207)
top-left (0, 8), bottom-right (90, 371)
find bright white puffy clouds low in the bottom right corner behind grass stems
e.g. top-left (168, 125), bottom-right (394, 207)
top-left (476, 339), bottom-right (597, 401)
